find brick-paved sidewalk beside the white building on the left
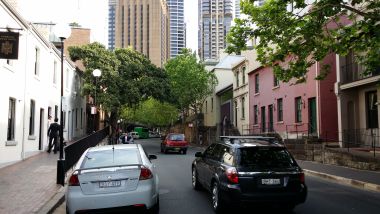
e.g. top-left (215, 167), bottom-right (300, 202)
top-left (0, 152), bottom-right (61, 214)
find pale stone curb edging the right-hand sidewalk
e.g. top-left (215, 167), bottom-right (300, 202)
top-left (304, 169), bottom-right (380, 192)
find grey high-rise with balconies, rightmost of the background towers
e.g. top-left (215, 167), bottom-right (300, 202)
top-left (198, 0), bottom-right (233, 60)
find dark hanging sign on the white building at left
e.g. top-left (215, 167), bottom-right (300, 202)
top-left (0, 32), bottom-right (19, 59)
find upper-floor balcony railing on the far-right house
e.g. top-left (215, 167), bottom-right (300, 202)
top-left (340, 63), bottom-right (380, 84)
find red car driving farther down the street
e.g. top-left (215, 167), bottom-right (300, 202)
top-left (161, 133), bottom-right (189, 154)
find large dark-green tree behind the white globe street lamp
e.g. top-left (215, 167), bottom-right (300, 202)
top-left (68, 42), bottom-right (169, 137)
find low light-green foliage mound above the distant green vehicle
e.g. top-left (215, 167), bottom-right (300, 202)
top-left (121, 98), bottom-right (178, 127)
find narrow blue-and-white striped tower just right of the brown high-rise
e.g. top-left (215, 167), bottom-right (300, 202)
top-left (167, 0), bottom-right (186, 58)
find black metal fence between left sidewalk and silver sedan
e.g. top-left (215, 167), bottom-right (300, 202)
top-left (65, 127), bottom-right (109, 172)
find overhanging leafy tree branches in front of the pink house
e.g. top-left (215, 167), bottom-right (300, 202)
top-left (227, 0), bottom-right (380, 82)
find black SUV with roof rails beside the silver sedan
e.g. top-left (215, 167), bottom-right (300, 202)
top-left (192, 136), bottom-right (307, 213)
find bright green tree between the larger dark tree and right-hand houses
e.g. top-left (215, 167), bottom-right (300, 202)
top-left (165, 49), bottom-right (217, 142)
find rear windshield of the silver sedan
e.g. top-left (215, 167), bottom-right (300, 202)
top-left (81, 149), bottom-right (140, 168)
